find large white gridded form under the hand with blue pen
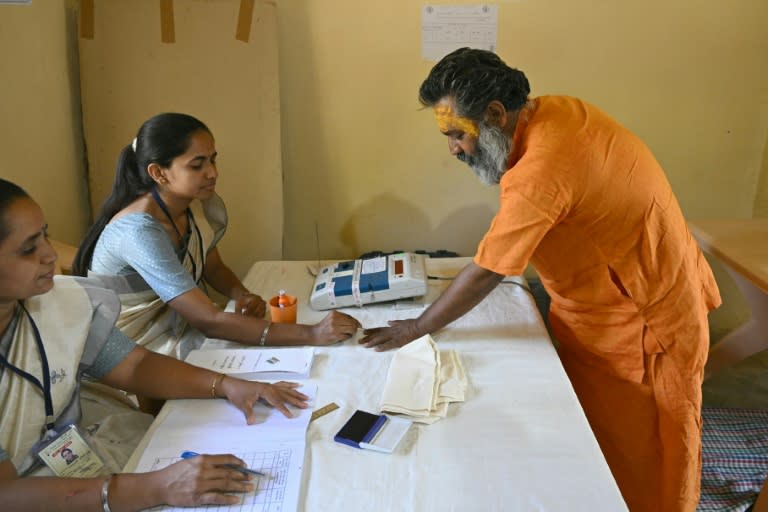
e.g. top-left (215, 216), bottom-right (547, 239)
top-left (136, 384), bottom-right (317, 512)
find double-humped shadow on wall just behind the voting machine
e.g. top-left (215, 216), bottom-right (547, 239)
top-left (339, 194), bottom-right (494, 256)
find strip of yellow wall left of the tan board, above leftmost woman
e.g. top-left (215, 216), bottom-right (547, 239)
top-left (0, 0), bottom-right (88, 244)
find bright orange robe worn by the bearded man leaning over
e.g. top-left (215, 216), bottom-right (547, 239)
top-left (475, 96), bottom-right (720, 512)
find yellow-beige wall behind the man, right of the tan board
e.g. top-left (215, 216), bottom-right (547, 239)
top-left (278, 0), bottom-right (768, 259)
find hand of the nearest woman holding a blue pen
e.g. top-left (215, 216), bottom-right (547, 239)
top-left (154, 455), bottom-right (253, 507)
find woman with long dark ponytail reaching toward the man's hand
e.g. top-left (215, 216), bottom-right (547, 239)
top-left (73, 113), bottom-right (360, 359)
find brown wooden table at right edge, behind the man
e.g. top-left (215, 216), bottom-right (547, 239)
top-left (688, 219), bottom-right (768, 377)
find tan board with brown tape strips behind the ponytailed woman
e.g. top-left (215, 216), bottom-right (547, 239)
top-left (80, 0), bottom-right (283, 276)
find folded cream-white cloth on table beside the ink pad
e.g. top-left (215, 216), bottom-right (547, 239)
top-left (380, 334), bottom-right (467, 423)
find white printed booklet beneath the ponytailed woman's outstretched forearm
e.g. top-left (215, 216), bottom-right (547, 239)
top-left (186, 347), bottom-right (315, 380)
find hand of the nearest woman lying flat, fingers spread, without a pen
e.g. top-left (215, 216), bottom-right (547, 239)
top-left (219, 376), bottom-right (309, 425)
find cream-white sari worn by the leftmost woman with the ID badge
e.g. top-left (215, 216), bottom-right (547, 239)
top-left (0, 276), bottom-right (152, 475)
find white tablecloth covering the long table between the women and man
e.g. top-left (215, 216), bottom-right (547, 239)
top-left (129, 258), bottom-right (626, 512)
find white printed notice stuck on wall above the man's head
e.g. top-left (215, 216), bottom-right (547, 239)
top-left (421, 5), bottom-right (498, 62)
